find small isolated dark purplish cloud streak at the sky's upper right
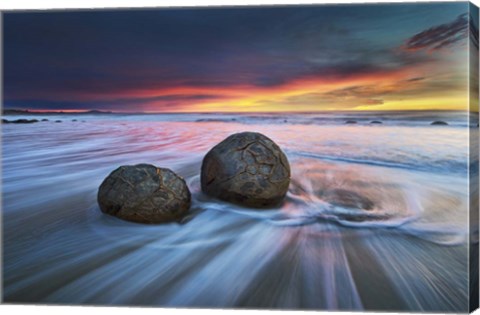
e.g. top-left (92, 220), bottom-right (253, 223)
top-left (405, 13), bottom-right (469, 51)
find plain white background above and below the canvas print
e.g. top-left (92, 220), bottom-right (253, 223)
top-left (0, 0), bottom-right (480, 315)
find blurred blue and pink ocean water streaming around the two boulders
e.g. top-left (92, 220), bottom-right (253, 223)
top-left (2, 112), bottom-right (478, 312)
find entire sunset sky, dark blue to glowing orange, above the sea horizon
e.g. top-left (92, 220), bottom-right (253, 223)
top-left (3, 2), bottom-right (478, 112)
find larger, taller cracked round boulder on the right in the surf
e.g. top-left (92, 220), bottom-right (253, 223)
top-left (201, 132), bottom-right (290, 208)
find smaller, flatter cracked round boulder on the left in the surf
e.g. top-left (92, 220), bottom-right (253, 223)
top-left (97, 164), bottom-right (191, 223)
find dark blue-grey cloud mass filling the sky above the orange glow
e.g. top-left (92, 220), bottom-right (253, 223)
top-left (3, 4), bottom-right (468, 110)
